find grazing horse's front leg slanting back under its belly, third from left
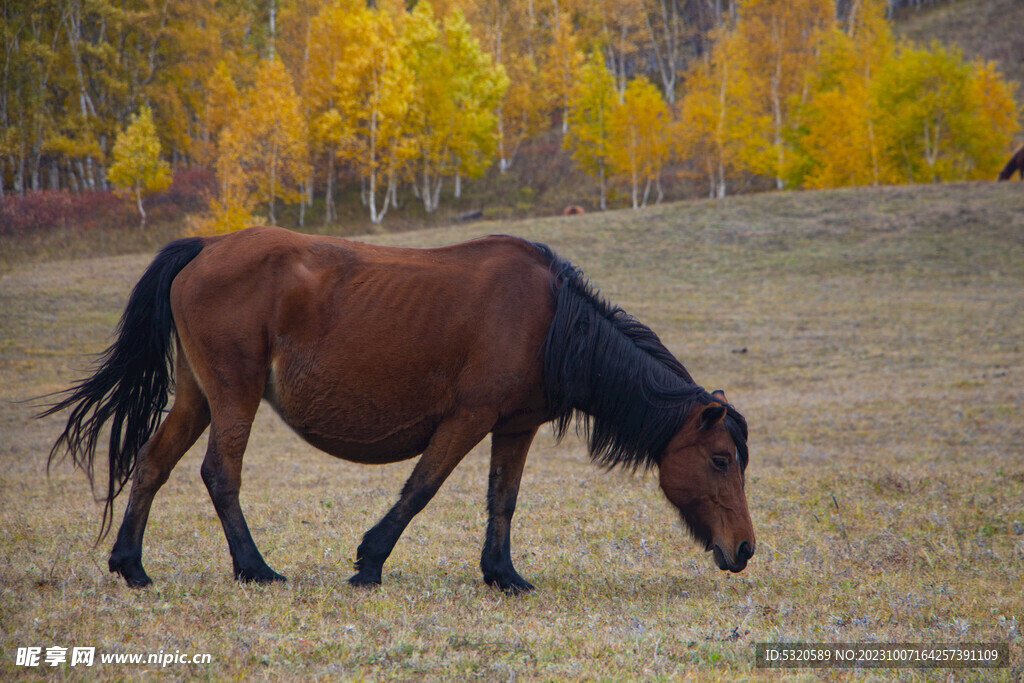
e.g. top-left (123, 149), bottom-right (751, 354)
top-left (348, 414), bottom-right (495, 585)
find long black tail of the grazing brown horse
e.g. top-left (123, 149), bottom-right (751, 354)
top-left (38, 238), bottom-right (204, 542)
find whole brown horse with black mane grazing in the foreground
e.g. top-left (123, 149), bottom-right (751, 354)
top-left (44, 227), bottom-right (755, 593)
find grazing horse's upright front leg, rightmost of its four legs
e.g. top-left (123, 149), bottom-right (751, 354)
top-left (480, 429), bottom-right (537, 594)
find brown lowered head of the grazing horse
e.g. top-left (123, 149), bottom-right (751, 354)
top-left (659, 391), bottom-right (756, 571)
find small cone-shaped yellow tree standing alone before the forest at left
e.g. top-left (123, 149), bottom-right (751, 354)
top-left (108, 105), bottom-right (171, 228)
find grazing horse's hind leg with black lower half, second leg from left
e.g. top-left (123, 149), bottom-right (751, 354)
top-left (201, 402), bottom-right (285, 584)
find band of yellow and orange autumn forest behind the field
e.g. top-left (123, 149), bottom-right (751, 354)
top-left (0, 0), bottom-right (1024, 236)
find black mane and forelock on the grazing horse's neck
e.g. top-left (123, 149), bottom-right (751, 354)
top-left (534, 243), bottom-right (748, 470)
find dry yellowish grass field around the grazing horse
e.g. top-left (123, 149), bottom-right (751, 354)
top-left (0, 182), bottom-right (1024, 681)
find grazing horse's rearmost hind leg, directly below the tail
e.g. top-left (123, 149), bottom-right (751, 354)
top-left (108, 351), bottom-right (210, 588)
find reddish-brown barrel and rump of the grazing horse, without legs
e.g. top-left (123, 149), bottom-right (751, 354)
top-left (172, 227), bottom-right (553, 462)
